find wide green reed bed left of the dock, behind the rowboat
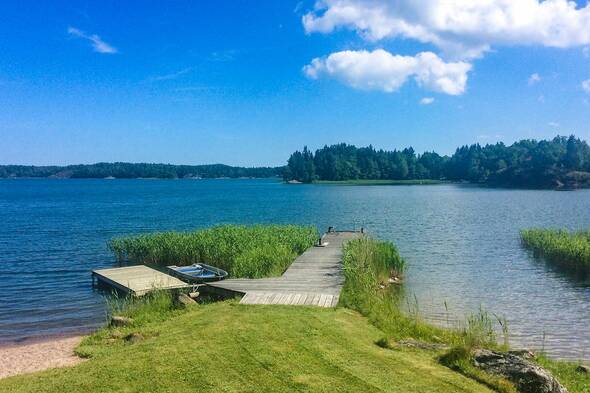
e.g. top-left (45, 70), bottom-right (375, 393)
top-left (109, 225), bottom-right (318, 278)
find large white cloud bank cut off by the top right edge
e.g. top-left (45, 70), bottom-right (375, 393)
top-left (303, 0), bottom-right (590, 59)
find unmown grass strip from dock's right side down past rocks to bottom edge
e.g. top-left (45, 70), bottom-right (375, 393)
top-left (340, 238), bottom-right (516, 393)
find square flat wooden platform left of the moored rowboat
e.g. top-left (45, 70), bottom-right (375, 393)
top-left (92, 265), bottom-right (192, 296)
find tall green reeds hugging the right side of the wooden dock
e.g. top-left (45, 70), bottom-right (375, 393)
top-left (340, 238), bottom-right (496, 347)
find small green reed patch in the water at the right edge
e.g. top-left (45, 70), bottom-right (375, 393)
top-left (520, 229), bottom-right (590, 274)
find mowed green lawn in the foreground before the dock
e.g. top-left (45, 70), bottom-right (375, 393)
top-left (0, 301), bottom-right (500, 393)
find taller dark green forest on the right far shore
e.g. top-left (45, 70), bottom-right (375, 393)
top-left (283, 135), bottom-right (590, 188)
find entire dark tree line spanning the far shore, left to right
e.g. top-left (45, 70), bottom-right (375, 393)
top-left (5, 135), bottom-right (590, 188)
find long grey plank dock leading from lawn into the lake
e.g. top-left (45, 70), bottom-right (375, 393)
top-left (207, 232), bottom-right (362, 307)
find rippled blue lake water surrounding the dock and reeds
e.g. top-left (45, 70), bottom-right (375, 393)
top-left (0, 180), bottom-right (590, 359)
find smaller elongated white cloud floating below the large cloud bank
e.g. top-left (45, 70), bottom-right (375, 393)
top-left (303, 49), bottom-right (471, 95)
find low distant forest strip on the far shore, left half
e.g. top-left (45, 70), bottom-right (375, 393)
top-left (0, 162), bottom-right (282, 179)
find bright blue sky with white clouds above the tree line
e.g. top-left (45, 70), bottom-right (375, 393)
top-left (0, 0), bottom-right (590, 166)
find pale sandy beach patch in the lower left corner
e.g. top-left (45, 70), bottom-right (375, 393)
top-left (0, 336), bottom-right (83, 378)
